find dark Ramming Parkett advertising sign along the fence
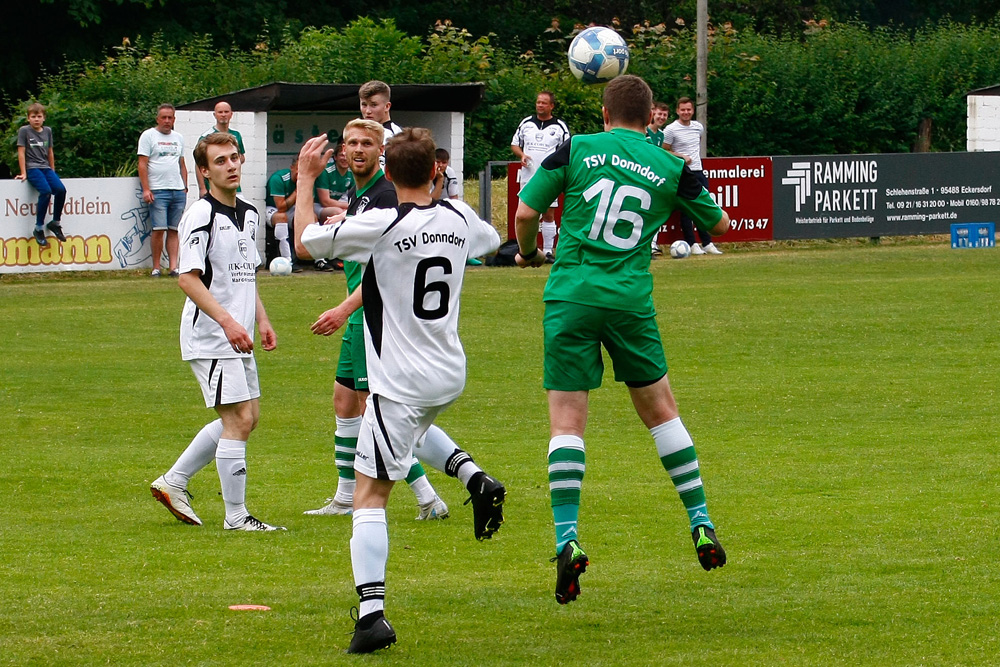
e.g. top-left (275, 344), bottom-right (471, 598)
top-left (773, 153), bottom-right (1000, 239)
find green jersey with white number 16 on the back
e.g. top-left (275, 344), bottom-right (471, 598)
top-left (519, 128), bottom-right (722, 312)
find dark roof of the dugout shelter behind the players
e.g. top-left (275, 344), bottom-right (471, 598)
top-left (177, 81), bottom-right (484, 112)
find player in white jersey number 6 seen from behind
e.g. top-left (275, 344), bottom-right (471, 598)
top-left (295, 128), bottom-right (502, 653)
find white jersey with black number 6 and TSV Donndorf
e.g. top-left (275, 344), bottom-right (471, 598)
top-left (302, 200), bottom-right (500, 406)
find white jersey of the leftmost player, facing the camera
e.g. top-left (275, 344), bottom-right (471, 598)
top-left (177, 194), bottom-right (261, 361)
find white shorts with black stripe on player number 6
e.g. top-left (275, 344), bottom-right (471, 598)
top-left (354, 394), bottom-right (451, 482)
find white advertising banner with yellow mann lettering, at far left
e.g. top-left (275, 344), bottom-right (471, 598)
top-left (0, 178), bottom-right (165, 273)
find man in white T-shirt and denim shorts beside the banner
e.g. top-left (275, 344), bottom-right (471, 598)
top-left (137, 104), bottom-right (187, 278)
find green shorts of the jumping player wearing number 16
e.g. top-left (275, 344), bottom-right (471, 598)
top-left (543, 301), bottom-right (667, 391)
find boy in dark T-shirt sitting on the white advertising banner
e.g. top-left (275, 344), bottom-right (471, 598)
top-left (14, 102), bottom-right (66, 248)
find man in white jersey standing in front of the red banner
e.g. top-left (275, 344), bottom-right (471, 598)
top-left (510, 90), bottom-right (569, 263)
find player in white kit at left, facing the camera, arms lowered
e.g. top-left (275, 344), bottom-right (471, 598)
top-left (150, 132), bottom-right (284, 531)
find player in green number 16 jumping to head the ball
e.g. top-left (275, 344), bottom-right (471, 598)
top-left (516, 75), bottom-right (729, 604)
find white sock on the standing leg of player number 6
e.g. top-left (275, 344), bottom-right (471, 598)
top-left (351, 508), bottom-right (389, 618)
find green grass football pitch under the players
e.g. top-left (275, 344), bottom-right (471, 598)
top-left (0, 243), bottom-right (1000, 666)
